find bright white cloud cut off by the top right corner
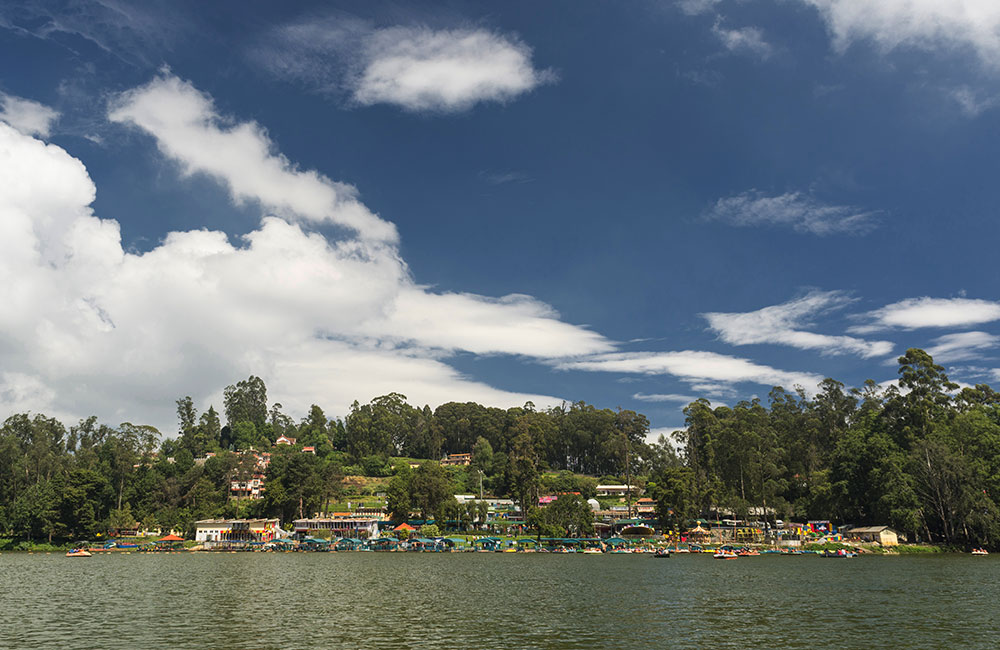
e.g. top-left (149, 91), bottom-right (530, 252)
top-left (801, 0), bottom-right (1000, 68)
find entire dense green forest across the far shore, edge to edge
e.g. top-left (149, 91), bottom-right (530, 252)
top-left (0, 349), bottom-right (1000, 546)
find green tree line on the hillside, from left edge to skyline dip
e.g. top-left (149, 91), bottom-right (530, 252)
top-left (0, 376), bottom-right (648, 541)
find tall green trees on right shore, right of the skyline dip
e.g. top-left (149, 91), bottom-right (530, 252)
top-left (651, 349), bottom-right (1000, 546)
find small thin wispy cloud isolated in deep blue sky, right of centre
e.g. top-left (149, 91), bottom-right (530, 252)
top-left (705, 189), bottom-right (877, 235)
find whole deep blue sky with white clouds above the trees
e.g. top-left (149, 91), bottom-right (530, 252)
top-left (0, 0), bottom-right (1000, 436)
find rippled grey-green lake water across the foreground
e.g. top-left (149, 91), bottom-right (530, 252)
top-left (0, 553), bottom-right (1000, 650)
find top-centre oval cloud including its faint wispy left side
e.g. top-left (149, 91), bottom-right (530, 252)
top-left (249, 21), bottom-right (555, 112)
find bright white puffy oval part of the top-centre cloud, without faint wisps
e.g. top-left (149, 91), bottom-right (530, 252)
top-left (354, 27), bottom-right (551, 111)
